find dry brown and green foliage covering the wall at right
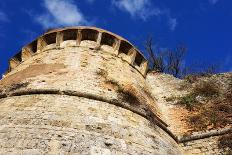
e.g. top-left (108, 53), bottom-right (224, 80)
top-left (177, 74), bottom-right (232, 131)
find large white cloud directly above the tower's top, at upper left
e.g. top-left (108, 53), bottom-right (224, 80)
top-left (36, 0), bottom-right (87, 28)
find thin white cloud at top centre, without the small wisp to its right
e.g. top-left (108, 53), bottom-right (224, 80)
top-left (112, 0), bottom-right (162, 20)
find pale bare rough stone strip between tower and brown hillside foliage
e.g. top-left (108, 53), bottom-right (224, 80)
top-left (146, 72), bottom-right (190, 135)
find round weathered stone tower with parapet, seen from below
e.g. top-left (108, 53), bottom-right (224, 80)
top-left (0, 27), bottom-right (181, 155)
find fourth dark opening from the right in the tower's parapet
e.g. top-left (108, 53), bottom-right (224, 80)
top-left (81, 29), bottom-right (99, 42)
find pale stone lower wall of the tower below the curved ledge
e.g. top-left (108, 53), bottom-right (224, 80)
top-left (0, 95), bottom-right (179, 155)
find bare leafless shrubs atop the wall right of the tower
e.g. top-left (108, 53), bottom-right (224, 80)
top-left (145, 37), bottom-right (220, 78)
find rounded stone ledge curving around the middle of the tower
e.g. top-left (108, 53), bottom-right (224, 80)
top-left (0, 89), bottom-right (177, 141)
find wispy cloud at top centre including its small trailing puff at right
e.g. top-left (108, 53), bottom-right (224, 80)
top-left (112, 0), bottom-right (178, 31)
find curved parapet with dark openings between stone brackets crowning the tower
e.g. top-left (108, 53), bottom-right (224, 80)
top-left (5, 27), bottom-right (148, 76)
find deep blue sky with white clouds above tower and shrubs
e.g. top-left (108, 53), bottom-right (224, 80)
top-left (0, 0), bottom-right (232, 77)
